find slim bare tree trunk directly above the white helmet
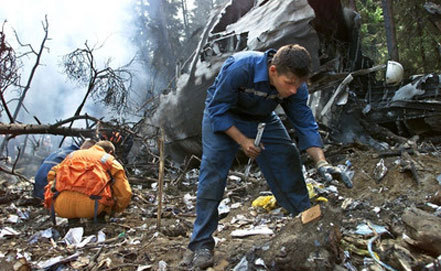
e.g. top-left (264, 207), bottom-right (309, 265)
top-left (381, 0), bottom-right (399, 61)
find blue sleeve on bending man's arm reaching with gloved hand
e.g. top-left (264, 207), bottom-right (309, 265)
top-left (281, 84), bottom-right (323, 151)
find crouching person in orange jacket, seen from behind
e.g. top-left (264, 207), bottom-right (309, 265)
top-left (44, 140), bottom-right (132, 223)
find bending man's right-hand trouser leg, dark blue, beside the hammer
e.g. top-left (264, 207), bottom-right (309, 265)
top-left (256, 117), bottom-right (310, 215)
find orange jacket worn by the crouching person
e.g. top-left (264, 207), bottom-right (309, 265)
top-left (45, 145), bottom-right (132, 212)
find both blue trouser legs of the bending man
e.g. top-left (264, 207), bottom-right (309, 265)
top-left (189, 112), bottom-right (310, 250)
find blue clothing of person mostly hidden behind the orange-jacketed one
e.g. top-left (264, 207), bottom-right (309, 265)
top-left (32, 144), bottom-right (79, 200)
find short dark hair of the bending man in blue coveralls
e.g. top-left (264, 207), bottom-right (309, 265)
top-left (271, 44), bottom-right (311, 78)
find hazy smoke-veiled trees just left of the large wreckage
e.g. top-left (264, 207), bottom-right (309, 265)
top-left (133, 0), bottom-right (227, 98)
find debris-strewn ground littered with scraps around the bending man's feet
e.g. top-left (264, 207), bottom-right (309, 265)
top-left (0, 141), bottom-right (441, 271)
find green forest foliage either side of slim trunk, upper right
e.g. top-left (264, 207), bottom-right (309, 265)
top-left (356, 0), bottom-right (441, 76)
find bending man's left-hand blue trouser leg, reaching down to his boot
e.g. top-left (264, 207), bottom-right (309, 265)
top-left (188, 112), bottom-right (239, 250)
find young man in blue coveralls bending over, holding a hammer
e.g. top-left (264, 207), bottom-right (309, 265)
top-left (181, 44), bottom-right (344, 268)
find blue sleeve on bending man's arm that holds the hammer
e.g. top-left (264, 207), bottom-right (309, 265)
top-left (206, 56), bottom-right (249, 132)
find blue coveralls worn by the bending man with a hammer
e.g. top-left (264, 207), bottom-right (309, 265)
top-left (188, 50), bottom-right (322, 251)
